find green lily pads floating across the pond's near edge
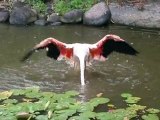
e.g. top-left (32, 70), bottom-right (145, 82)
top-left (0, 87), bottom-right (160, 120)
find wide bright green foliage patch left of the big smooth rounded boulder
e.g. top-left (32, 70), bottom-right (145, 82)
top-left (54, 0), bottom-right (97, 14)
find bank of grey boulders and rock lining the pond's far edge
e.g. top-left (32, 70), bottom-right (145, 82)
top-left (0, 0), bottom-right (160, 29)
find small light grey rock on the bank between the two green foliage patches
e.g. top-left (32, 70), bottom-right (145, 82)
top-left (47, 13), bottom-right (60, 23)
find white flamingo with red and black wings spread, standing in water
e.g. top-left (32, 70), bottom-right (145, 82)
top-left (21, 34), bottom-right (138, 85)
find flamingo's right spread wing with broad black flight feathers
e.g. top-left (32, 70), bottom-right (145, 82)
top-left (90, 34), bottom-right (138, 60)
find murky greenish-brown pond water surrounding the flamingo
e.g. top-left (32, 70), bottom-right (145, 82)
top-left (0, 24), bottom-right (160, 108)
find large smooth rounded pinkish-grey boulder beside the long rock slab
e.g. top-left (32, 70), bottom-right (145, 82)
top-left (83, 2), bottom-right (111, 26)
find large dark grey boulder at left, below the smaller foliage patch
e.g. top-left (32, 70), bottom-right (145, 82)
top-left (9, 6), bottom-right (37, 25)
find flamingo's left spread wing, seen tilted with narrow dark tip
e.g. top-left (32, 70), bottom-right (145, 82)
top-left (22, 38), bottom-right (73, 61)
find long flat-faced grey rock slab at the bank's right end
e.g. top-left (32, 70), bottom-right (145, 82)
top-left (109, 1), bottom-right (160, 28)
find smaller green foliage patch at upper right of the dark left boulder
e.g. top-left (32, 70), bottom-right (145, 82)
top-left (25, 0), bottom-right (47, 13)
